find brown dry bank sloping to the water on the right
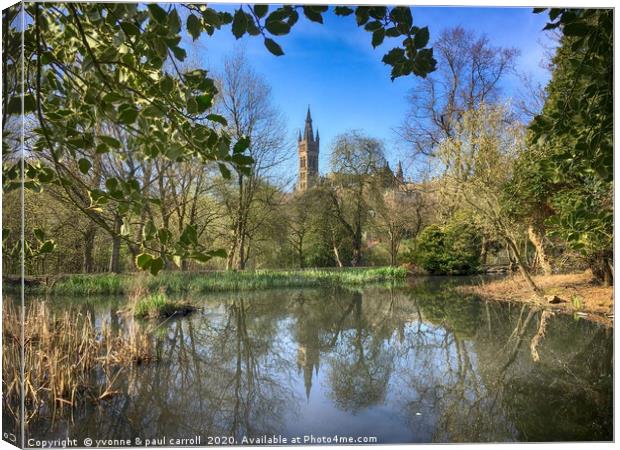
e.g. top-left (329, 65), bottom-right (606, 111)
top-left (459, 271), bottom-right (614, 324)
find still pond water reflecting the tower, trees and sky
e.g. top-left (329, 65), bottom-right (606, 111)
top-left (27, 280), bottom-right (613, 445)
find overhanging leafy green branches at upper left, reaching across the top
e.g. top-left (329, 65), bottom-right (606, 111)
top-left (2, 3), bottom-right (435, 274)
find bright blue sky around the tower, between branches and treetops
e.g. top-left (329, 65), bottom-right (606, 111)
top-left (188, 5), bottom-right (549, 180)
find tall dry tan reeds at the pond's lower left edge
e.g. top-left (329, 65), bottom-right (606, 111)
top-left (2, 302), bottom-right (153, 422)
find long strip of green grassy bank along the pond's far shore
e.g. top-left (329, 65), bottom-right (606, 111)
top-left (13, 267), bottom-right (407, 295)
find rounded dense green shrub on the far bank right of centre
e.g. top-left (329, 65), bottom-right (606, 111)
top-left (413, 220), bottom-right (482, 275)
